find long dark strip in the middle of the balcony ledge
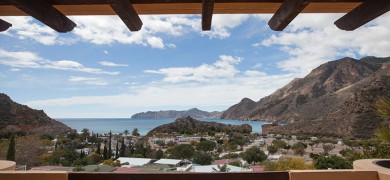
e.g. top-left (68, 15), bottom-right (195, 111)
top-left (68, 172), bottom-right (289, 180)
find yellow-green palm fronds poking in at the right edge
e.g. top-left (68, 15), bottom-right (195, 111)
top-left (375, 97), bottom-right (390, 143)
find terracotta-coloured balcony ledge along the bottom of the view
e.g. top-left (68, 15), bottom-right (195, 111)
top-left (0, 160), bottom-right (390, 180)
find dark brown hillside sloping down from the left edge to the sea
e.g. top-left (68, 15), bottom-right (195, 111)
top-left (0, 93), bottom-right (72, 135)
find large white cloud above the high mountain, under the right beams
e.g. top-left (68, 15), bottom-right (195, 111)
top-left (261, 13), bottom-right (390, 76)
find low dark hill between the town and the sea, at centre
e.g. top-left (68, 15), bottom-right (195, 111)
top-left (147, 117), bottom-right (252, 136)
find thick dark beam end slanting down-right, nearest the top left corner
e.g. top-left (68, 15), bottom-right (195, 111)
top-left (9, 0), bottom-right (76, 32)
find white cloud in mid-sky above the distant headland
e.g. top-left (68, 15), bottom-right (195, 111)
top-left (144, 55), bottom-right (242, 83)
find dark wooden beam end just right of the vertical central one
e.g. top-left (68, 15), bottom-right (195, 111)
top-left (268, 0), bottom-right (310, 31)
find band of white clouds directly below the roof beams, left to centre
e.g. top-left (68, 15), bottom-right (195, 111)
top-left (0, 15), bottom-right (250, 47)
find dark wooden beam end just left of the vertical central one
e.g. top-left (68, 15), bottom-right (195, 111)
top-left (108, 0), bottom-right (142, 31)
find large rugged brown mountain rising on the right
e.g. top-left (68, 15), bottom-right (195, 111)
top-left (222, 57), bottom-right (390, 138)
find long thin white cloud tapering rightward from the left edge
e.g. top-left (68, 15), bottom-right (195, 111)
top-left (0, 49), bottom-right (119, 75)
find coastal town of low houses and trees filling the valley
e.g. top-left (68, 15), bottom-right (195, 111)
top-left (0, 117), bottom-right (390, 173)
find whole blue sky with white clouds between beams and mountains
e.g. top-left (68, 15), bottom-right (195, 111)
top-left (0, 13), bottom-right (390, 118)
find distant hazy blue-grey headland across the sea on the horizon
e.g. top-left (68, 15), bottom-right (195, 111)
top-left (131, 108), bottom-right (222, 119)
